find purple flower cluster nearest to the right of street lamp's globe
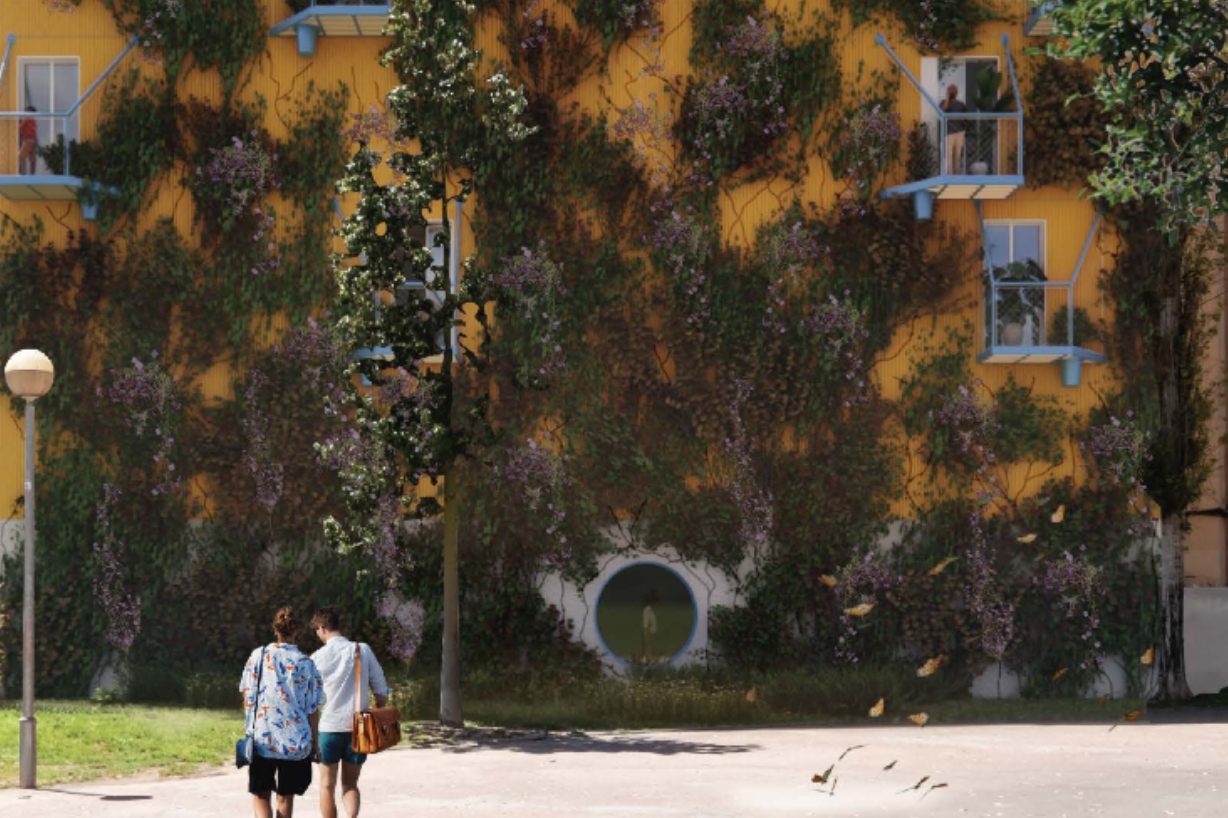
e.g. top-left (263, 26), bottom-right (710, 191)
top-left (97, 353), bottom-right (181, 497)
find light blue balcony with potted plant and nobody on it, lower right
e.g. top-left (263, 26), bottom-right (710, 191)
top-left (976, 215), bottom-right (1105, 387)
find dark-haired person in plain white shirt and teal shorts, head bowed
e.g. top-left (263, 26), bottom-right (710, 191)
top-left (311, 608), bottom-right (388, 818)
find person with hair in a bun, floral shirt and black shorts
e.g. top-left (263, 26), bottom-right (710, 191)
top-left (238, 607), bottom-right (323, 818)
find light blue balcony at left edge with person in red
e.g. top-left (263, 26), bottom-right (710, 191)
top-left (0, 34), bottom-right (138, 221)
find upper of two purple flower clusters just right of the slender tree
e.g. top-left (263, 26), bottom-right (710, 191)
top-left (492, 242), bottom-right (567, 377)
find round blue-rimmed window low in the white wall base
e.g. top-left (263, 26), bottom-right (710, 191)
top-left (596, 560), bottom-right (699, 667)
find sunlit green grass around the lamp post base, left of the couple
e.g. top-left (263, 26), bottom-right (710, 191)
top-left (0, 700), bottom-right (243, 787)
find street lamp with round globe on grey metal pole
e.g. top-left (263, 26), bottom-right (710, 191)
top-left (4, 349), bottom-right (55, 790)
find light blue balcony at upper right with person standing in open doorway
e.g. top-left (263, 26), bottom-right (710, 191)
top-left (876, 34), bottom-right (1024, 220)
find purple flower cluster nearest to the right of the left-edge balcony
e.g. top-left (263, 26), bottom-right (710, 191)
top-left (196, 130), bottom-right (281, 275)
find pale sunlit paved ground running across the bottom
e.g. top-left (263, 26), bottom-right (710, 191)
top-left (0, 722), bottom-right (1228, 818)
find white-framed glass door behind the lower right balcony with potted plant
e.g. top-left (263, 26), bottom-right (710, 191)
top-left (985, 221), bottom-right (1047, 346)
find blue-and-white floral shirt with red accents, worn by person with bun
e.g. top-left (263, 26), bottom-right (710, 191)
top-left (238, 642), bottom-right (323, 759)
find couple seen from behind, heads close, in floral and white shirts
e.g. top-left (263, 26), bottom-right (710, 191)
top-left (238, 608), bottom-right (388, 818)
